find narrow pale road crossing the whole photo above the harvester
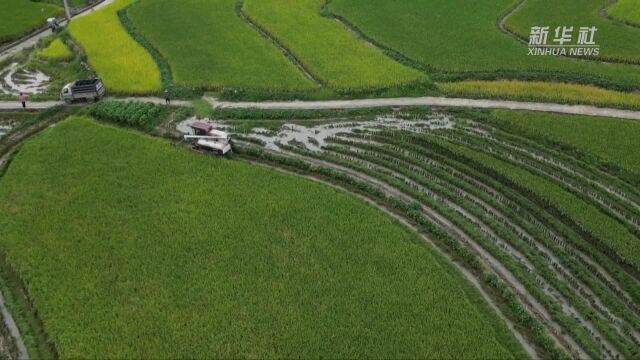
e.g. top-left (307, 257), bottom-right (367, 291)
top-left (0, 97), bottom-right (640, 121)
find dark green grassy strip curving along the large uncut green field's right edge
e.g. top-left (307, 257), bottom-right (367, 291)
top-left (239, 144), bottom-right (566, 359)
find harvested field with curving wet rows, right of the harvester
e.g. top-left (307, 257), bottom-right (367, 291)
top-left (236, 111), bottom-right (640, 359)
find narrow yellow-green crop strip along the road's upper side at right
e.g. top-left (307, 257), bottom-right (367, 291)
top-left (438, 81), bottom-right (640, 109)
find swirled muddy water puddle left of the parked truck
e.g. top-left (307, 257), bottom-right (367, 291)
top-left (0, 63), bottom-right (51, 95)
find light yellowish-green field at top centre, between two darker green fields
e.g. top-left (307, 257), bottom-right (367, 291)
top-left (243, 0), bottom-right (427, 91)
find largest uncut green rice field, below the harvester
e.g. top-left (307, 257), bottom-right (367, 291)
top-left (0, 118), bottom-right (526, 358)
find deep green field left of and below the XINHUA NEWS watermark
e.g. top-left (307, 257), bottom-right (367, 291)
top-left (329, 0), bottom-right (640, 89)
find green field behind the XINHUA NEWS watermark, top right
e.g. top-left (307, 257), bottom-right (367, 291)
top-left (507, 0), bottom-right (640, 64)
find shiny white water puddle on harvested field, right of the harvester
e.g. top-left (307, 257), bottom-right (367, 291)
top-left (240, 115), bottom-right (454, 151)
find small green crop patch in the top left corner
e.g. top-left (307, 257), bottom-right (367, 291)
top-left (0, 0), bottom-right (63, 43)
